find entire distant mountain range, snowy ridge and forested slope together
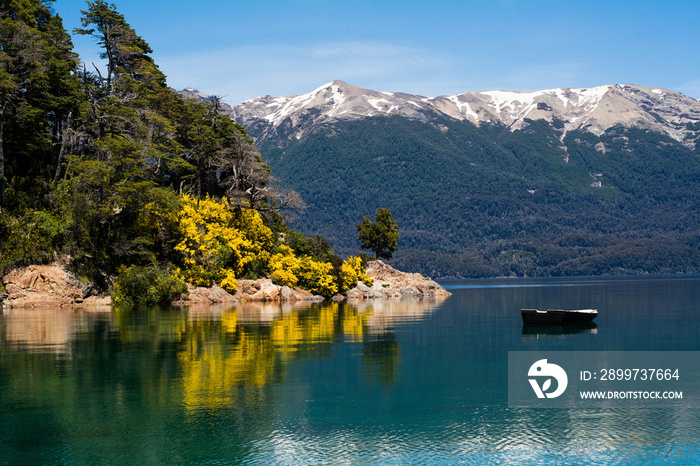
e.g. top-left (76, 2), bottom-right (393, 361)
top-left (182, 81), bottom-right (700, 277)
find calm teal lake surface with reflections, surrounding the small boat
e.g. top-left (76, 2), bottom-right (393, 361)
top-left (0, 276), bottom-right (700, 465)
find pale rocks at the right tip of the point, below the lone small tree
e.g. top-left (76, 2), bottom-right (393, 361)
top-left (334, 260), bottom-right (451, 301)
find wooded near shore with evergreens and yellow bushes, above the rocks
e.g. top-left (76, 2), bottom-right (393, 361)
top-left (0, 0), bottom-right (368, 303)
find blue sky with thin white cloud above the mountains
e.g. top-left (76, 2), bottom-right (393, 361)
top-left (53, 0), bottom-right (700, 105)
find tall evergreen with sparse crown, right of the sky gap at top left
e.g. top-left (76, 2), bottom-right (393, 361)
top-left (68, 0), bottom-right (181, 278)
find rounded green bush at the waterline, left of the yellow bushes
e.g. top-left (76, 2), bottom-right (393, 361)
top-left (112, 265), bottom-right (187, 306)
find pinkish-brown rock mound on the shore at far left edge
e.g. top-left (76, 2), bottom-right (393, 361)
top-left (2, 263), bottom-right (112, 308)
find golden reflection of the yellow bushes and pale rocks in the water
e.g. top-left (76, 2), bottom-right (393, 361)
top-left (178, 301), bottom-right (437, 412)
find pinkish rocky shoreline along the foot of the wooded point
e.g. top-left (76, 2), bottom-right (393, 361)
top-left (0, 261), bottom-right (450, 310)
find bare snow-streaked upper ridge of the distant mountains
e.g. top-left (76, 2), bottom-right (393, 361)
top-left (233, 81), bottom-right (700, 146)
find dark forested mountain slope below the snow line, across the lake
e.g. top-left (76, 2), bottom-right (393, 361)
top-left (250, 114), bottom-right (700, 277)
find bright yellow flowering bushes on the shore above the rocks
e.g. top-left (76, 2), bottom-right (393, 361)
top-left (170, 195), bottom-right (372, 297)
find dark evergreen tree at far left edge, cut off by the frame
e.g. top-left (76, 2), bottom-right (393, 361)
top-left (0, 0), bottom-right (80, 208)
